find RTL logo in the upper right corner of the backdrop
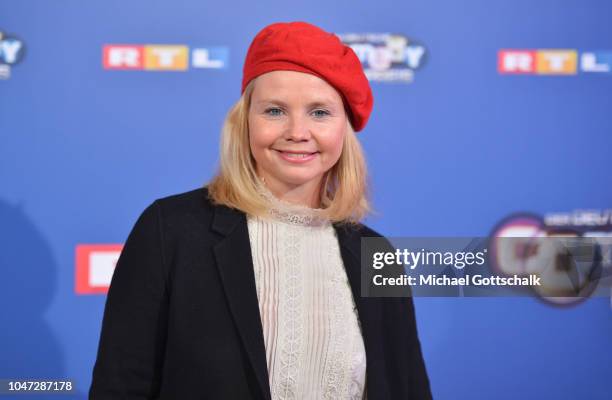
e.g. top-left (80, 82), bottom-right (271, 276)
top-left (497, 49), bottom-right (612, 75)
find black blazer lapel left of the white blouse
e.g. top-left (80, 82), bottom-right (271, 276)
top-left (212, 206), bottom-right (272, 400)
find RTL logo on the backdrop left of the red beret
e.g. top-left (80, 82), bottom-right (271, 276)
top-left (102, 44), bottom-right (229, 71)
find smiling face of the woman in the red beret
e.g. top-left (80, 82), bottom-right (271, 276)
top-left (248, 71), bottom-right (348, 190)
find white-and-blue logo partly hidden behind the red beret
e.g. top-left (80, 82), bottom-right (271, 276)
top-left (337, 33), bottom-right (427, 83)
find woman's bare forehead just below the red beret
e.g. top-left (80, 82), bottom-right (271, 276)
top-left (253, 71), bottom-right (342, 102)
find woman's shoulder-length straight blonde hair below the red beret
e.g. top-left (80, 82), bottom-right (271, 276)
top-left (207, 80), bottom-right (371, 224)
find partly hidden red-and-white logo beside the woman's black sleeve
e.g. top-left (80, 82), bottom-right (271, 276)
top-left (75, 244), bottom-right (123, 294)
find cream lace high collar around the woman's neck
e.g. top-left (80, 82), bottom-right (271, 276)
top-left (256, 181), bottom-right (330, 226)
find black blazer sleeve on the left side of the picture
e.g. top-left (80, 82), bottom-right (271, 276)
top-left (89, 200), bottom-right (169, 400)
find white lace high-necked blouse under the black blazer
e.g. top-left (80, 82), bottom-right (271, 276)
top-left (248, 185), bottom-right (366, 400)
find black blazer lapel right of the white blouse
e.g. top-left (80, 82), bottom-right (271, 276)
top-left (334, 224), bottom-right (389, 400)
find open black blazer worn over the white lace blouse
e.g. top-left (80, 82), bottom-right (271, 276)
top-left (89, 187), bottom-right (431, 400)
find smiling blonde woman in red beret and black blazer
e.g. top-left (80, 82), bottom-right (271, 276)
top-left (89, 22), bottom-right (431, 400)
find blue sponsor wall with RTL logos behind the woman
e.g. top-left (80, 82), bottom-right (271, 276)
top-left (0, 0), bottom-right (612, 399)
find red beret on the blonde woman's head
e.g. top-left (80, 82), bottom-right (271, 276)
top-left (241, 22), bottom-right (374, 132)
